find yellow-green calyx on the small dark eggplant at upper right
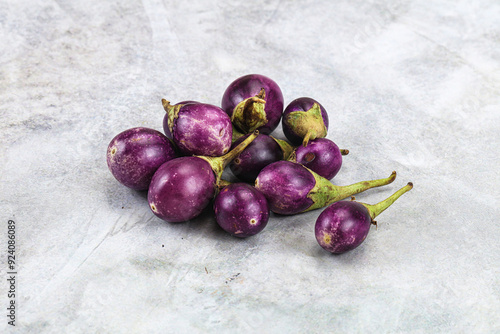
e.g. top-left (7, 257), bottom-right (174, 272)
top-left (286, 103), bottom-right (327, 146)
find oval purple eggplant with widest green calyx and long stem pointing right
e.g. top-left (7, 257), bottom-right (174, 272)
top-left (255, 161), bottom-right (396, 215)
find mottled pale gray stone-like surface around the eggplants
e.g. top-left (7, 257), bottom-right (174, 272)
top-left (0, 0), bottom-right (500, 333)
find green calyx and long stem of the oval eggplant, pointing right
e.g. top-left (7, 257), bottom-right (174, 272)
top-left (303, 169), bottom-right (396, 212)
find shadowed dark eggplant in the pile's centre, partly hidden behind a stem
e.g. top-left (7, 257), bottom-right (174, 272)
top-left (229, 134), bottom-right (283, 183)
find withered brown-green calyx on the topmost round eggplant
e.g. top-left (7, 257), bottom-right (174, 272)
top-left (231, 88), bottom-right (267, 133)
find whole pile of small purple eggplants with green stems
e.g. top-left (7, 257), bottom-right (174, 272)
top-left (107, 74), bottom-right (413, 254)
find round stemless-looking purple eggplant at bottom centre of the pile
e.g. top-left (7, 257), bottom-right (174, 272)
top-left (214, 183), bottom-right (269, 238)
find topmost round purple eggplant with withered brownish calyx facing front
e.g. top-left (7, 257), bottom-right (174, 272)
top-left (221, 74), bottom-right (283, 134)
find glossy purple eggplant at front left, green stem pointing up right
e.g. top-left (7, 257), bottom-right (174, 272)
top-left (148, 131), bottom-right (258, 222)
